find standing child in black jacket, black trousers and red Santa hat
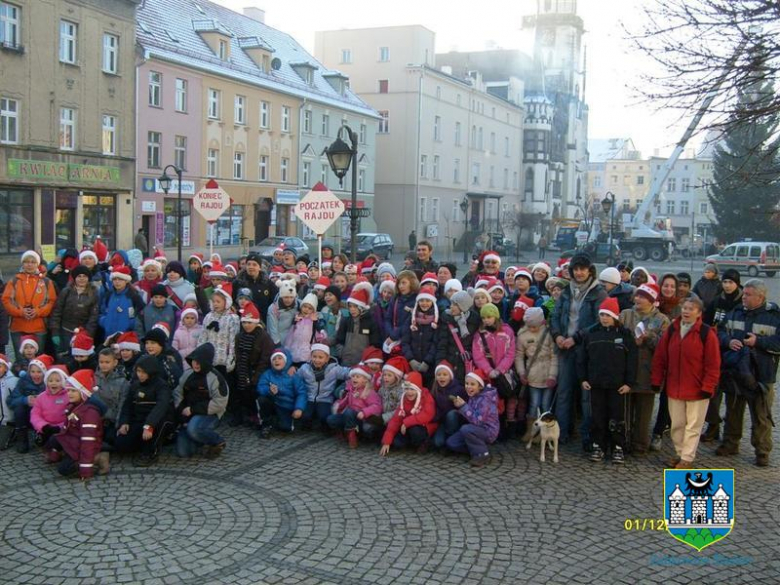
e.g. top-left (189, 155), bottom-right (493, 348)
top-left (577, 297), bottom-right (637, 464)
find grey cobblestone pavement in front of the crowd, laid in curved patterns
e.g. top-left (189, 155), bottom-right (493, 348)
top-left (0, 394), bottom-right (780, 585)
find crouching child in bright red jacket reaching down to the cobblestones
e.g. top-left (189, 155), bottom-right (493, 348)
top-left (379, 372), bottom-right (438, 457)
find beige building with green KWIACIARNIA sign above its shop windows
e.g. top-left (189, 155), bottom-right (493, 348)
top-left (0, 0), bottom-right (139, 269)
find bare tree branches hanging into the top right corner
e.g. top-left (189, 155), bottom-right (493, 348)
top-left (626, 0), bottom-right (780, 134)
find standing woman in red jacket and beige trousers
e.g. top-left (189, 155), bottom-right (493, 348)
top-left (651, 295), bottom-right (720, 469)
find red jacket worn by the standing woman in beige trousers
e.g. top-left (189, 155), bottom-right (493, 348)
top-left (650, 317), bottom-right (720, 400)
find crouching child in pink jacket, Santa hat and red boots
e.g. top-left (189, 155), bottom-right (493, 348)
top-left (328, 365), bottom-right (382, 449)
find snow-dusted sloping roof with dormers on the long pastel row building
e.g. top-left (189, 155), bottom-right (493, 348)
top-left (136, 0), bottom-right (379, 118)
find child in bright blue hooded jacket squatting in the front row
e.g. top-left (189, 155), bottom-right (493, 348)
top-left (257, 348), bottom-right (306, 439)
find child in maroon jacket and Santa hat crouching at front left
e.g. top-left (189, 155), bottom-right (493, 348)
top-left (47, 370), bottom-right (109, 481)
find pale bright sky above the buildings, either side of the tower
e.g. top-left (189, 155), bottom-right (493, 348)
top-left (215, 0), bottom-right (698, 156)
